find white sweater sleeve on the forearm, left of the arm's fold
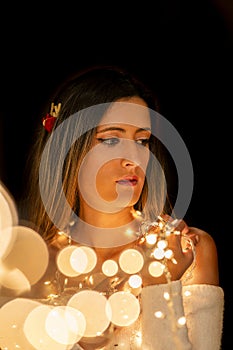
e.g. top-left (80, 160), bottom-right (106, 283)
top-left (141, 281), bottom-right (192, 350)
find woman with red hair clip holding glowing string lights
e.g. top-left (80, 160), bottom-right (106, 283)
top-left (22, 67), bottom-right (224, 350)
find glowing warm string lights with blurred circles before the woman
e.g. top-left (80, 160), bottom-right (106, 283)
top-left (0, 206), bottom-right (195, 350)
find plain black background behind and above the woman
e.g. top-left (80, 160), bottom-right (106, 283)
top-left (0, 0), bottom-right (233, 350)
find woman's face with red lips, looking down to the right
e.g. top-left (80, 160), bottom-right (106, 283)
top-left (79, 97), bottom-right (151, 213)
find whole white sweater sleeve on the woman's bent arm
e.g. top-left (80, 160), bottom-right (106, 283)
top-left (141, 281), bottom-right (224, 350)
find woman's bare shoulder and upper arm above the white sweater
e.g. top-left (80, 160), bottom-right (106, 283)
top-left (185, 227), bottom-right (219, 285)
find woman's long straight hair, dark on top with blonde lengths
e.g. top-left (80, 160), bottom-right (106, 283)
top-left (23, 67), bottom-right (169, 240)
